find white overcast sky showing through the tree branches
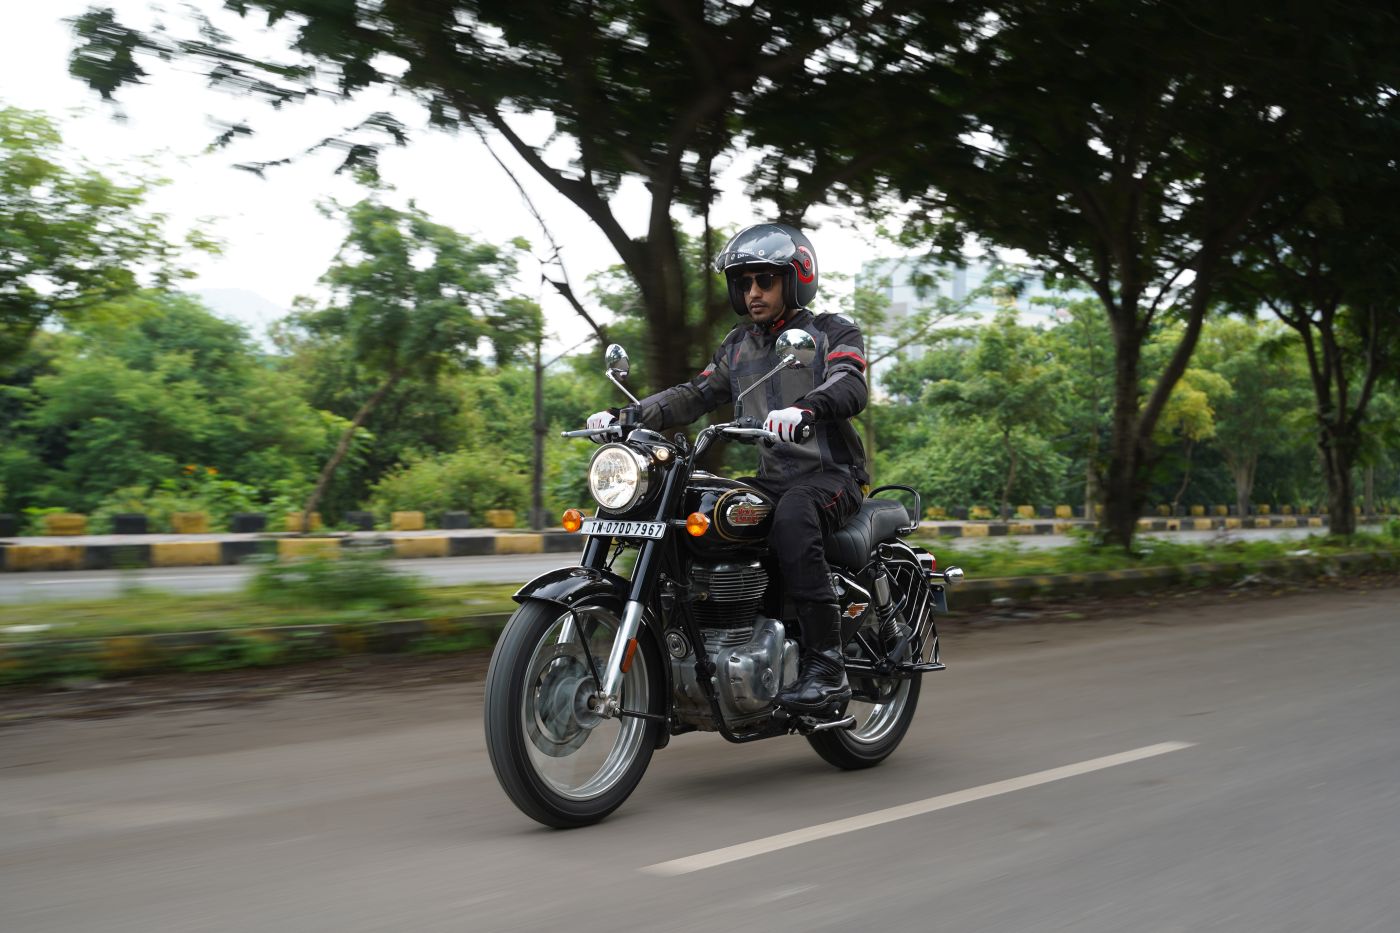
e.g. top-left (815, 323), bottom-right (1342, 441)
top-left (0, 0), bottom-right (876, 349)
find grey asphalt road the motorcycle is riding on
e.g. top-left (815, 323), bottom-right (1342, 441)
top-left (0, 590), bottom-right (1400, 933)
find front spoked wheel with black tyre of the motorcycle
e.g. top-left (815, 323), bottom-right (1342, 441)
top-left (484, 602), bottom-right (662, 828)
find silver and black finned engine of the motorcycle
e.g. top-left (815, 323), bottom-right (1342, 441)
top-left (666, 560), bottom-right (798, 730)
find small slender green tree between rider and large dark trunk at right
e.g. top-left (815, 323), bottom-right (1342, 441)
top-left (925, 308), bottom-right (1063, 520)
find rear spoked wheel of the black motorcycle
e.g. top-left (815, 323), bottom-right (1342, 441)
top-left (806, 642), bottom-right (923, 770)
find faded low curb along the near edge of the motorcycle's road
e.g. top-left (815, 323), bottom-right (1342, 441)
top-left (0, 552), bottom-right (1400, 685)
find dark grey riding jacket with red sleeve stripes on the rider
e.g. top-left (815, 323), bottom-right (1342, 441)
top-left (641, 310), bottom-right (869, 490)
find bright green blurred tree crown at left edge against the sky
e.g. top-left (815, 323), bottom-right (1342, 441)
top-left (0, 106), bottom-right (213, 371)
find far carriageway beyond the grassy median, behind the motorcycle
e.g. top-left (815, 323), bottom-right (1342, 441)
top-left (0, 528), bottom-right (1360, 602)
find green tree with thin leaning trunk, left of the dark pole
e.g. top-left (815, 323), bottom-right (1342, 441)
top-left (295, 196), bottom-right (540, 528)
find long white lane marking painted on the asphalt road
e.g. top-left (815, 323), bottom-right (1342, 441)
top-left (641, 742), bottom-right (1196, 877)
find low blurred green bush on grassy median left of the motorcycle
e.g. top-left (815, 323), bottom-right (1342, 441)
top-left (248, 552), bottom-right (427, 609)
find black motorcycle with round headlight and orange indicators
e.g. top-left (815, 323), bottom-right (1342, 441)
top-left (484, 329), bottom-right (963, 828)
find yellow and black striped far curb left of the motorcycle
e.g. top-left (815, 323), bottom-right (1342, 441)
top-left (0, 531), bottom-right (584, 572)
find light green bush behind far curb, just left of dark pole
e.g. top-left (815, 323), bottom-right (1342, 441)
top-left (370, 450), bottom-right (529, 523)
